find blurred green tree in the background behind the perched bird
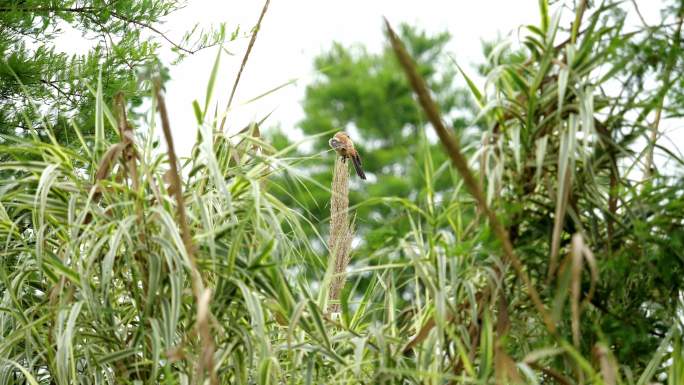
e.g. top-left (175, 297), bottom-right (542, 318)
top-left (273, 25), bottom-right (474, 250)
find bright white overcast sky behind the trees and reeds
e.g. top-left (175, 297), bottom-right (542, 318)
top-left (154, 0), bottom-right (672, 160)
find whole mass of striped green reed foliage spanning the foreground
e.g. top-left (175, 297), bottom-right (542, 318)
top-left (0, 1), bottom-right (684, 385)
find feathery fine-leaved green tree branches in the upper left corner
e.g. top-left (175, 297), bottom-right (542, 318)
top-left (0, 0), bottom-right (223, 143)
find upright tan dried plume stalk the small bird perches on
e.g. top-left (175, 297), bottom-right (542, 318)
top-left (328, 157), bottom-right (354, 313)
